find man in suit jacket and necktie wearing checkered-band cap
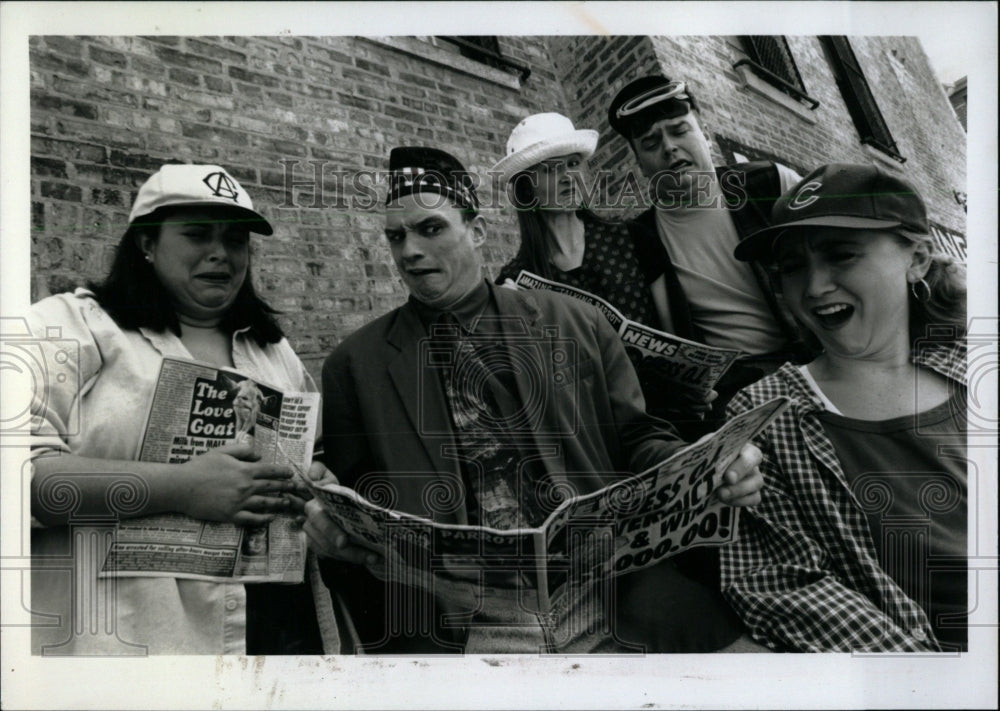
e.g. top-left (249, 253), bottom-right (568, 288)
top-left (305, 148), bottom-right (761, 653)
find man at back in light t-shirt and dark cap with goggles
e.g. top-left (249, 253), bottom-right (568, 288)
top-left (608, 75), bottom-right (808, 420)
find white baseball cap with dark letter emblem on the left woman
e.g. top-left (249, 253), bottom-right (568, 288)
top-left (128, 164), bottom-right (274, 235)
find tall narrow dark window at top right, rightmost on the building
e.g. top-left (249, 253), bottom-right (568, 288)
top-left (819, 36), bottom-right (906, 163)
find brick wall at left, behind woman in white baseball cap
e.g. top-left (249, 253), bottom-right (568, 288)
top-left (29, 36), bottom-right (565, 373)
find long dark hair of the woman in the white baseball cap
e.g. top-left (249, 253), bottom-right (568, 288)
top-left (89, 208), bottom-right (285, 347)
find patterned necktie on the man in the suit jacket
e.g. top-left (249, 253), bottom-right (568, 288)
top-left (435, 314), bottom-right (542, 529)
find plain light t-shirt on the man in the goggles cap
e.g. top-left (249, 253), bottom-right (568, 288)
top-left (656, 166), bottom-right (799, 354)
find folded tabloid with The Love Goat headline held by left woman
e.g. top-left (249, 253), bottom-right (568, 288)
top-left (101, 358), bottom-right (319, 583)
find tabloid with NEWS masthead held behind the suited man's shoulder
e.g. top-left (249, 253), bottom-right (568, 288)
top-left (514, 270), bottom-right (740, 396)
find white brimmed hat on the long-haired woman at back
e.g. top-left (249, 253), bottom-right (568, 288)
top-left (493, 113), bottom-right (598, 182)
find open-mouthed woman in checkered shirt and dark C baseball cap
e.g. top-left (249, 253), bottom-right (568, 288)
top-left (722, 164), bottom-right (968, 652)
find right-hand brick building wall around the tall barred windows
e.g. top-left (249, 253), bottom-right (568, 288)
top-left (549, 36), bottom-right (965, 238)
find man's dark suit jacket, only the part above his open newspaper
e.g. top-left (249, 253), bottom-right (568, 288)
top-left (323, 285), bottom-right (682, 523)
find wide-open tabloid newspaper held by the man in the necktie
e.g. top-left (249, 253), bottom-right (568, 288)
top-left (309, 398), bottom-right (788, 613)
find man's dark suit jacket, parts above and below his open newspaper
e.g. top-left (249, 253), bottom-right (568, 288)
top-left (322, 285), bottom-right (738, 653)
